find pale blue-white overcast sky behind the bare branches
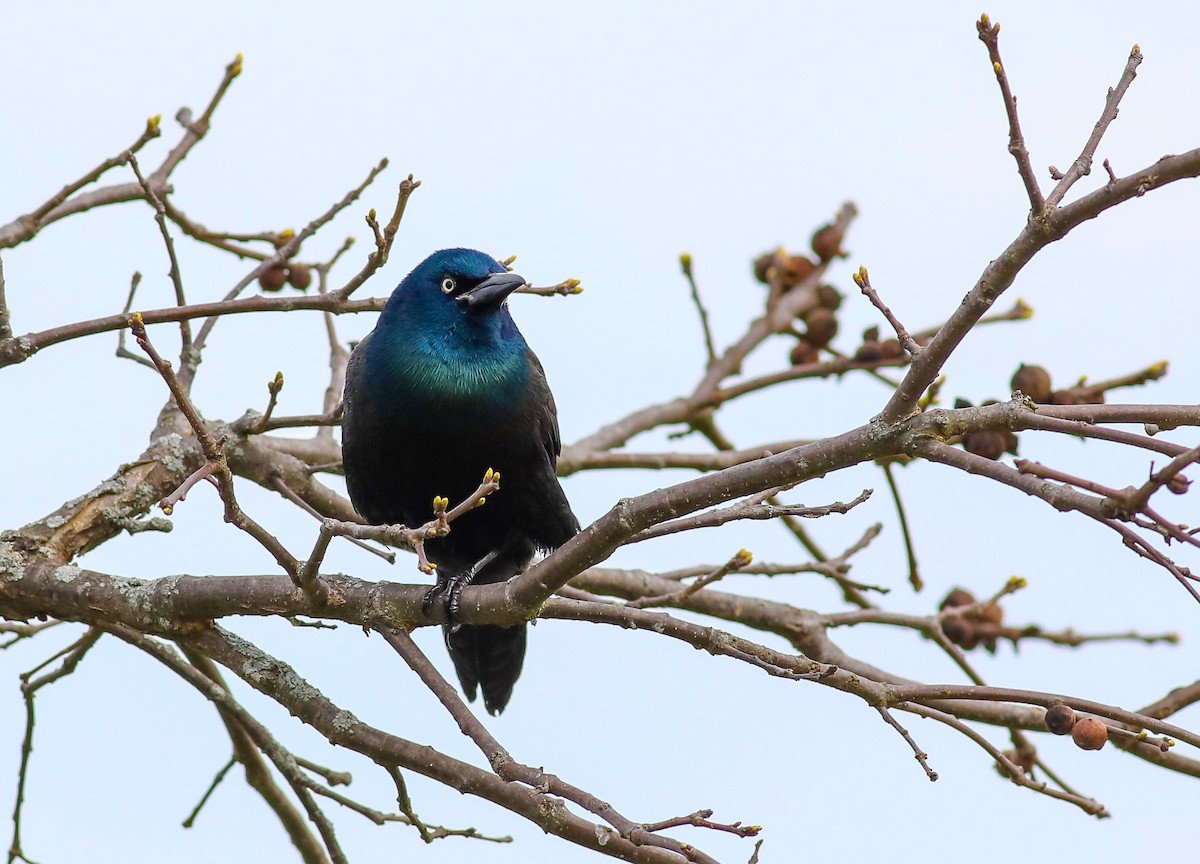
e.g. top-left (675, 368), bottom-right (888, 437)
top-left (0, 0), bottom-right (1200, 864)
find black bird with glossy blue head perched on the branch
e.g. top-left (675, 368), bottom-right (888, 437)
top-left (342, 248), bottom-right (580, 715)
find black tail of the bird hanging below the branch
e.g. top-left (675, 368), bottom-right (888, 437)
top-left (443, 624), bottom-right (526, 714)
